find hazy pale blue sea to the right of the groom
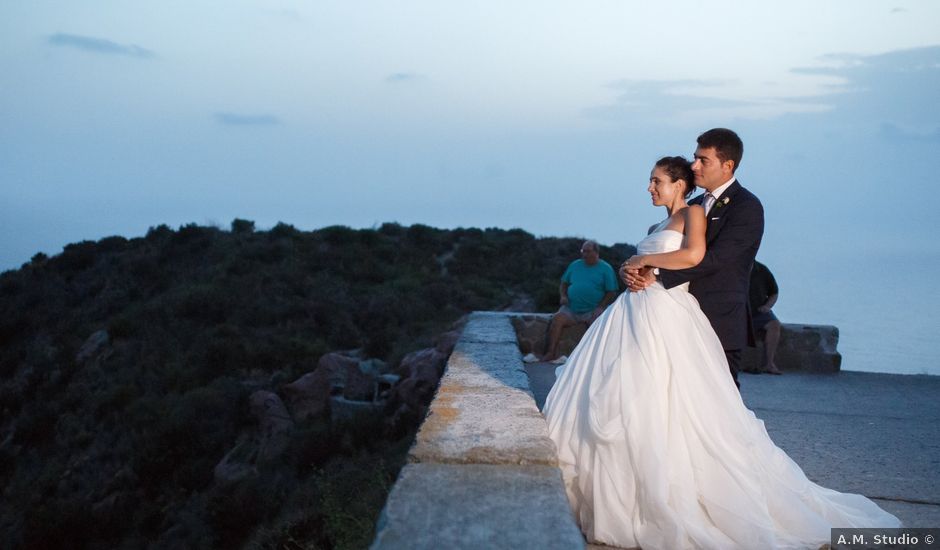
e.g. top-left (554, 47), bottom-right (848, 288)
top-left (762, 252), bottom-right (940, 376)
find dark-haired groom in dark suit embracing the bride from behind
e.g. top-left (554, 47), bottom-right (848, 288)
top-left (620, 128), bottom-right (764, 387)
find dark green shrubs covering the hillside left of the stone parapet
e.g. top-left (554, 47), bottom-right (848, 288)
top-left (0, 220), bottom-right (633, 549)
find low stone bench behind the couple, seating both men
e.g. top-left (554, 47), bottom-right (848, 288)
top-left (512, 313), bottom-right (842, 373)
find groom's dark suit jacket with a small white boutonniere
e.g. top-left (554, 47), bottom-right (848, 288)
top-left (659, 181), bottom-right (764, 350)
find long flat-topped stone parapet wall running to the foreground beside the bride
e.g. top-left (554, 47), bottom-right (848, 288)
top-left (372, 312), bottom-right (584, 550)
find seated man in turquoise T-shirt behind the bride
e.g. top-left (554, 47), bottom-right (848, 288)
top-left (541, 240), bottom-right (619, 362)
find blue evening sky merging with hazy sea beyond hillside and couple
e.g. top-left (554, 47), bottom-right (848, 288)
top-left (0, 0), bottom-right (940, 374)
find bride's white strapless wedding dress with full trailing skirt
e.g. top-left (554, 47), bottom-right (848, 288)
top-left (544, 224), bottom-right (900, 550)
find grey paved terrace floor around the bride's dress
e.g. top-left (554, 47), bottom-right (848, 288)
top-left (526, 363), bottom-right (940, 527)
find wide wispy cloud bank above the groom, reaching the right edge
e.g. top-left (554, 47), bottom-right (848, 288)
top-left (582, 46), bottom-right (940, 130)
